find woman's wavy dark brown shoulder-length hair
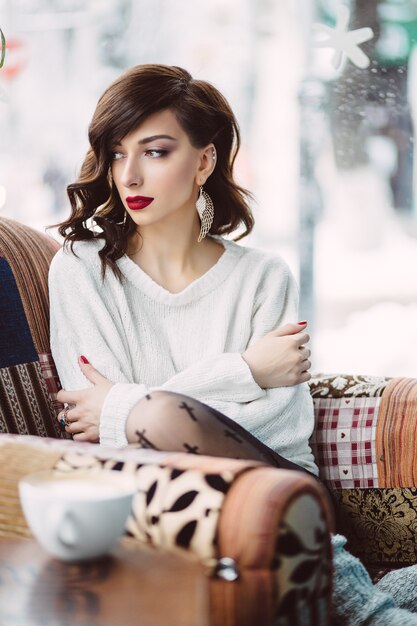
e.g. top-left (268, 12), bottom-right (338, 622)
top-left (57, 64), bottom-right (254, 277)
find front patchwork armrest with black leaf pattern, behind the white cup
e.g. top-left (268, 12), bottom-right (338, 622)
top-left (0, 435), bottom-right (332, 626)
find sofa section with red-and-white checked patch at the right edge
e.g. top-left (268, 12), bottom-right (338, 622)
top-left (310, 375), bottom-right (417, 569)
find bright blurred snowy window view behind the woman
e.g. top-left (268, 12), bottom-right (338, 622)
top-left (0, 0), bottom-right (417, 377)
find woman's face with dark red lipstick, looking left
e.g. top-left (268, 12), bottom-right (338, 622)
top-left (111, 109), bottom-right (214, 232)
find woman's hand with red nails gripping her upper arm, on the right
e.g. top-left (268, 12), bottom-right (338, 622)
top-left (242, 322), bottom-right (311, 389)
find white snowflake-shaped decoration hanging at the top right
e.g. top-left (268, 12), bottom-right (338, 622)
top-left (313, 5), bottom-right (374, 69)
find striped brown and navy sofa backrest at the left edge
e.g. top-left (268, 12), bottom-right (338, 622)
top-left (0, 218), bottom-right (62, 437)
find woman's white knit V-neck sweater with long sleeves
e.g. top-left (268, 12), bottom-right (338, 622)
top-left (49, 237), bottom-right (317, 473)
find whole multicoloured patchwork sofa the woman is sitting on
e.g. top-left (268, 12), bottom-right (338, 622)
top-left (0, 218), bottom-right (417, 626)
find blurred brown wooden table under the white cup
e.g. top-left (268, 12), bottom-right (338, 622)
top-left (0, 539), bottom-right (209, 626)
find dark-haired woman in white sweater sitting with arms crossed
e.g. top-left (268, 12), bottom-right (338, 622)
top-left (50, 65), bottom-right (417, 624)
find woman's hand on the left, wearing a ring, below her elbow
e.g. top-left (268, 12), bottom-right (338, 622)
top-left (57, 357), bottom-right (113, 443)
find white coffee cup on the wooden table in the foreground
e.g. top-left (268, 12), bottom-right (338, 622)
top-left (19, 470), bottom-right (136, 561)
